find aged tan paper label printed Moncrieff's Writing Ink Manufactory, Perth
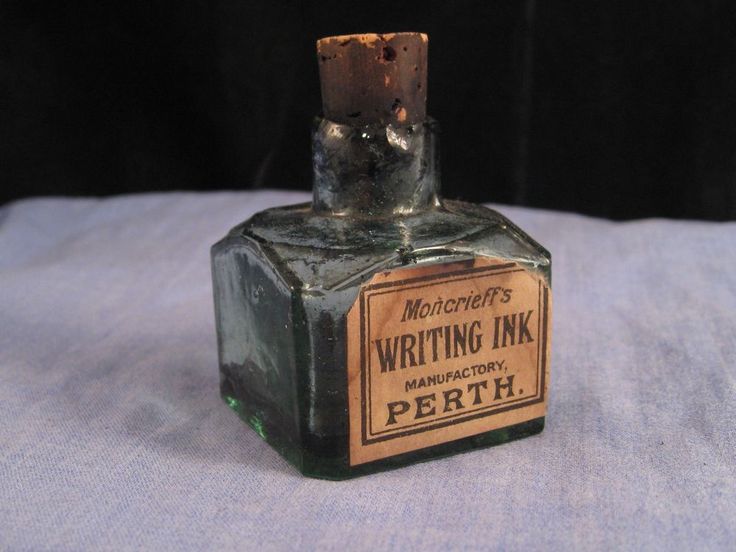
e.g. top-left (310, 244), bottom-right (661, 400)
top-left (347, 257), bottom-right (552, 466)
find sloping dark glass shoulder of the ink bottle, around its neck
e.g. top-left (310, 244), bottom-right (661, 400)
top-left (213, 200), bottom-right (550, 294)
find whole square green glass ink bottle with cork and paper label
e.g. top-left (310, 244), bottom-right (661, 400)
top-left (212, 33), bottom-right (551, 479)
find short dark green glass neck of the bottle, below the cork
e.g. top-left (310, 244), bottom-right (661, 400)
top-left (312, 119), bottom-right (440, 217)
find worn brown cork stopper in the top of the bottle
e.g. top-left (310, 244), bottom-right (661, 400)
top-left (317, 33), bottom-right (427, 126)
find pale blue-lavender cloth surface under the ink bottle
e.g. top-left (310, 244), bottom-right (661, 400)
top-left (0, 192), bottom-right (736, 550)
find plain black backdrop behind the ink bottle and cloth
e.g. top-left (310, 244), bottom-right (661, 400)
top-left (0, 0), bottom-right (736, 220)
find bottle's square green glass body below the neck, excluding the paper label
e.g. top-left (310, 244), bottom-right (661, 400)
top-left (212, 200), bottom-right (551, 479)
